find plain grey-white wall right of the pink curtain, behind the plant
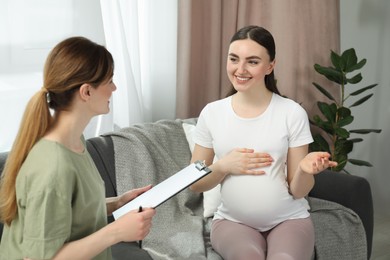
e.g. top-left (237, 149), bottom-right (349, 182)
top-left (340, 0), bottom-right (390, 214)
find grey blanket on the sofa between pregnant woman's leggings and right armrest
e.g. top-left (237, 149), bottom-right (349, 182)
top-left (309, 197), bottom-right (367, 260)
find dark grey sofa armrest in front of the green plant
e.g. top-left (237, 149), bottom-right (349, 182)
top-left (309, 170), bottom-right (374, 258)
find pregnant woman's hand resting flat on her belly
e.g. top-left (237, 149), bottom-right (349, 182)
top-left (218, 148), bottom-right (274, 175)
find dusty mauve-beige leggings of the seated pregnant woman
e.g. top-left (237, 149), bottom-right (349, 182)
top-left (210, 217), bottom-right (314, 260)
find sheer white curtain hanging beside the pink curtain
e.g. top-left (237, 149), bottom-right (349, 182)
top-left (100, 0), bottom-right (177, 130)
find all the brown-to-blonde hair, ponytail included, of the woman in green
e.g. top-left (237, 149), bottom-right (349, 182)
top-left (0, 37), bottom-right (114, 225)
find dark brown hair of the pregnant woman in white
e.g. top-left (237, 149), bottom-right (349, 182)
top-left (227, 25), bottom-right (280, 96)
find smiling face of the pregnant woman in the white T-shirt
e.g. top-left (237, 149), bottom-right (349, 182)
top-left (226, 39), bottom-right (275, 92)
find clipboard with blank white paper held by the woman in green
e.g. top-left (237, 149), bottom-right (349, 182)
top-left (112, 161), bottom-right (211, 219)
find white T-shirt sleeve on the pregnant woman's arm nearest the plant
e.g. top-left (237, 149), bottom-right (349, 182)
top-left (288, 103), bottom-right (313, 147)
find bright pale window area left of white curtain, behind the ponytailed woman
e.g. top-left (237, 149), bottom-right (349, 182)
top-left (0, 0), bottom-right (104, 152)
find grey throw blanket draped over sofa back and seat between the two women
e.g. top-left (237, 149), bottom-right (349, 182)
top-left (108, 120), bottom-right (221, 260)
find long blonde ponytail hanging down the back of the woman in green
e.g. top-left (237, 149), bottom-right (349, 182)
top-left (0, 88), bottom-right (52, 225)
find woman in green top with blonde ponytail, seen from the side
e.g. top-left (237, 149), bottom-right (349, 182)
top-left (0, 37), bottom-right (155, 260)
